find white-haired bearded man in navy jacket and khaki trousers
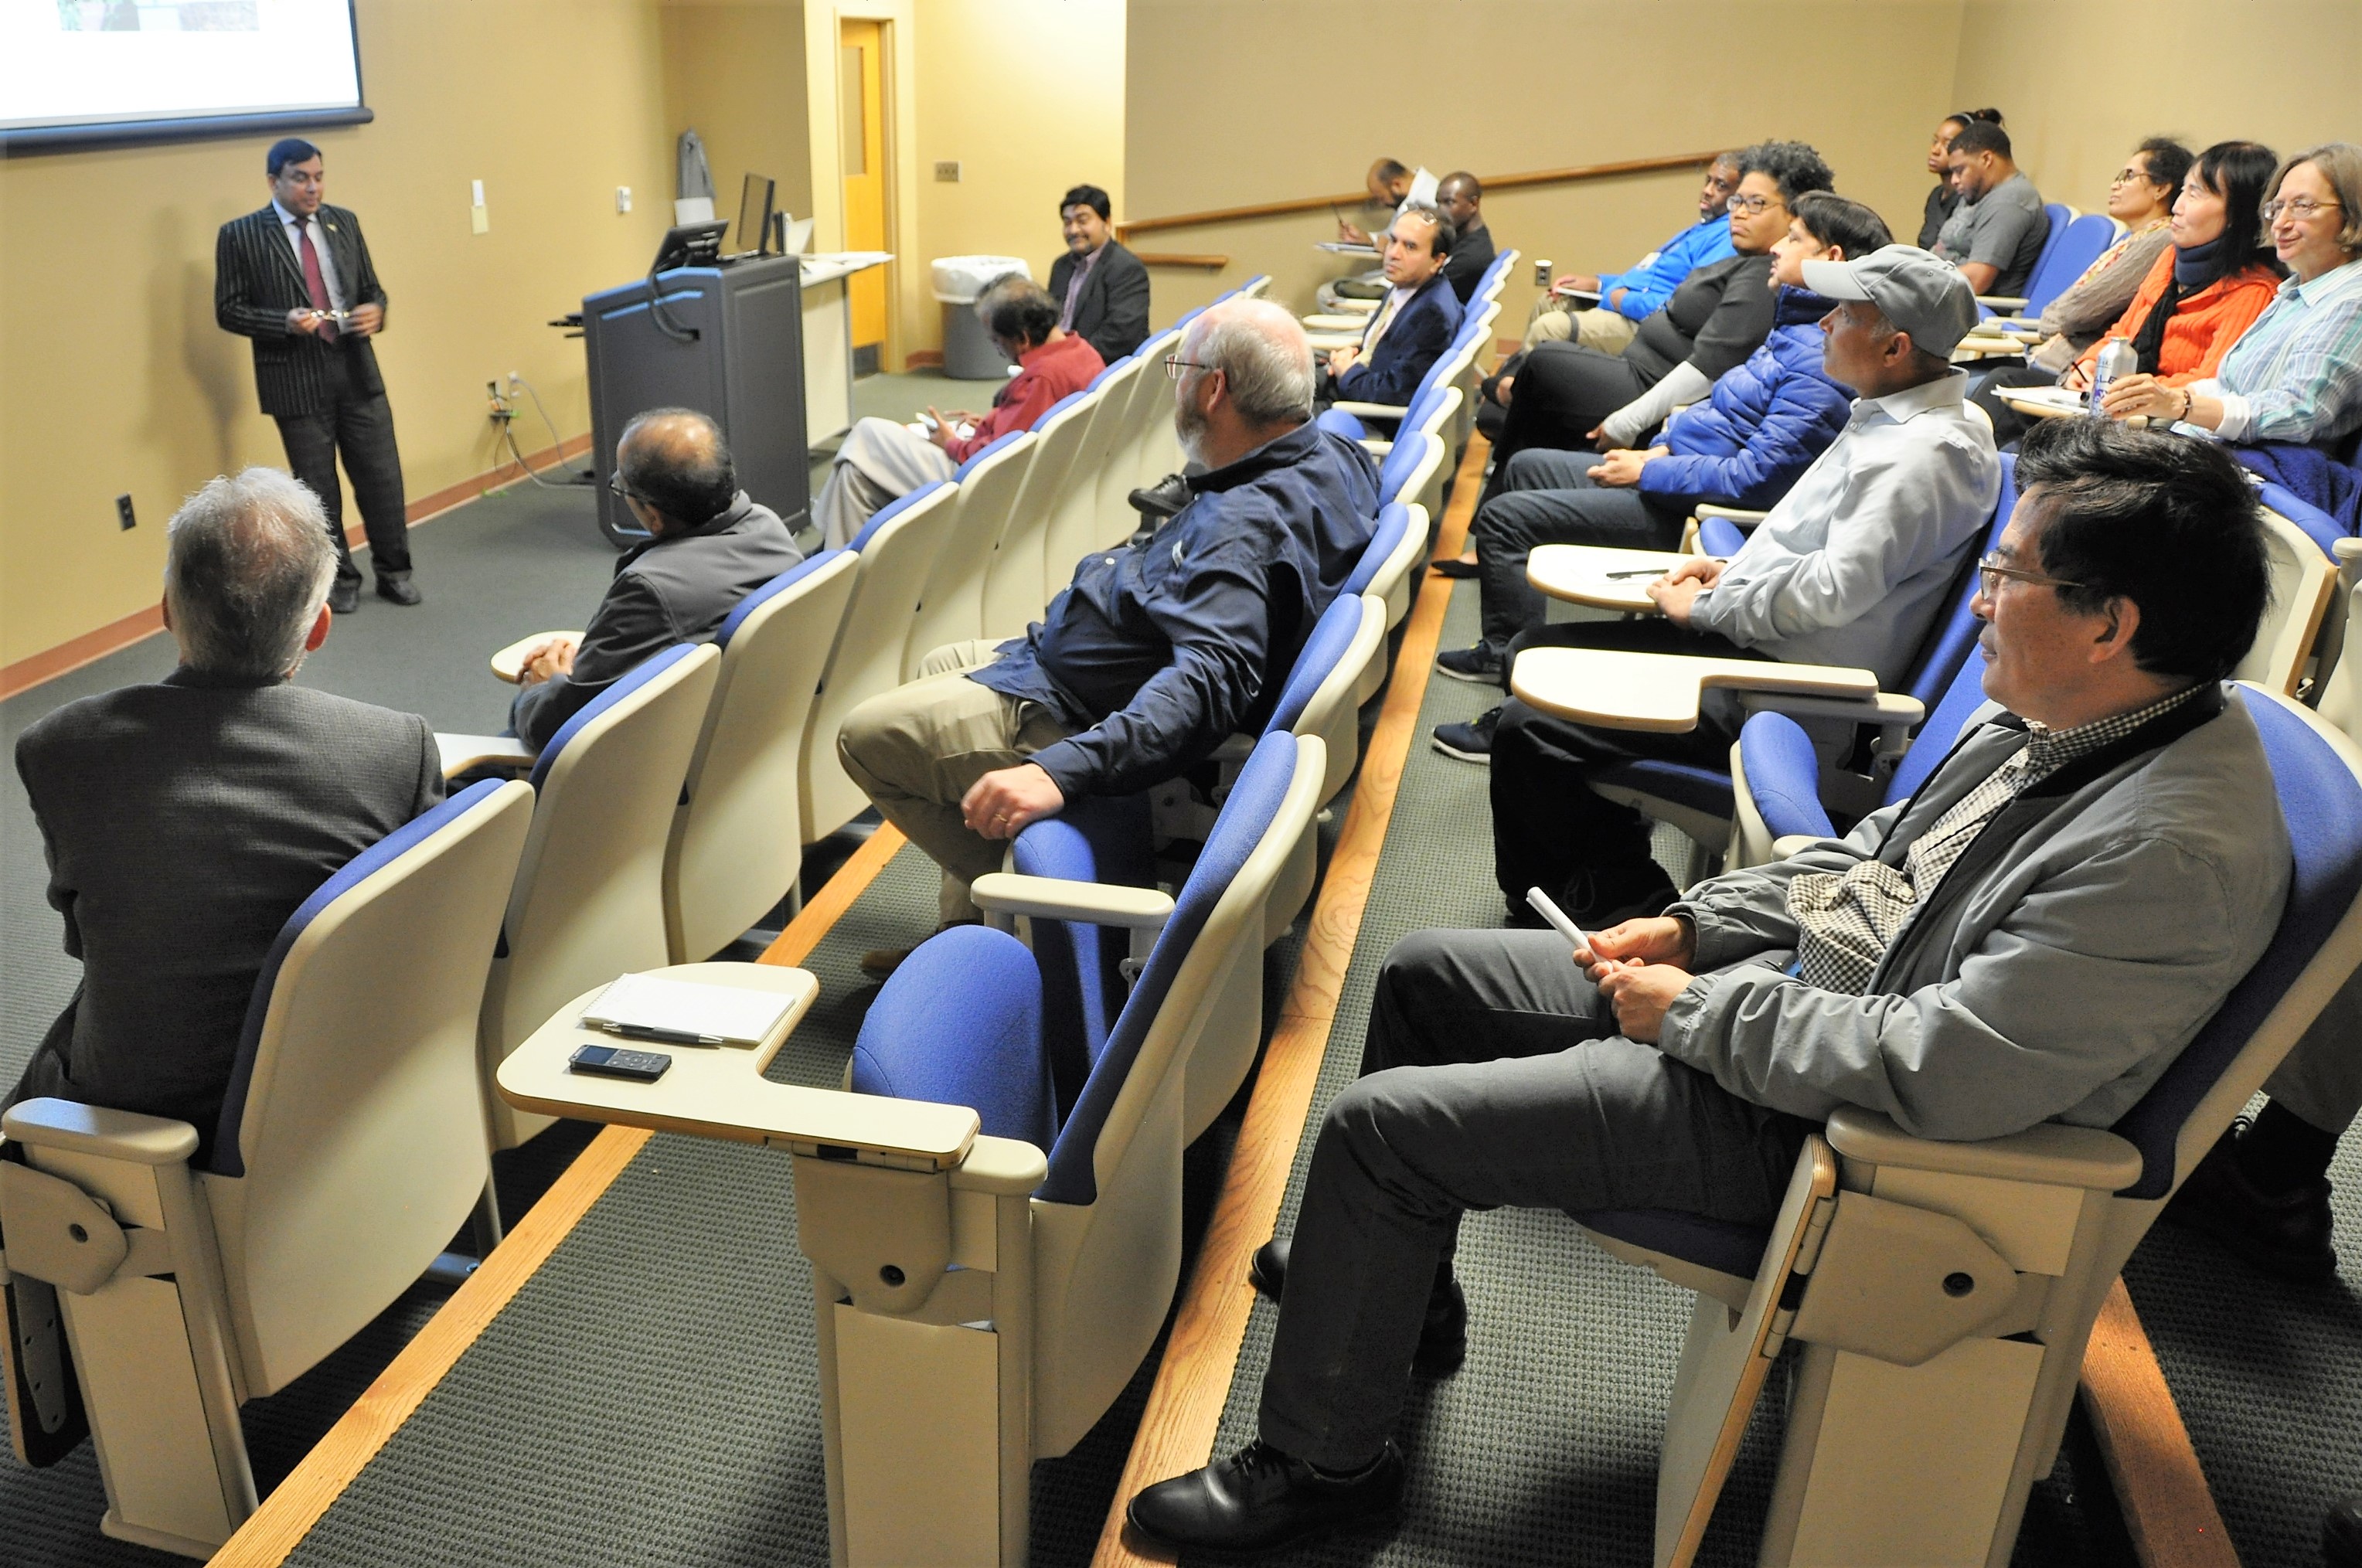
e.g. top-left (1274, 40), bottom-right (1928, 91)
top-left (836, 300), bottom-right (1377, 975)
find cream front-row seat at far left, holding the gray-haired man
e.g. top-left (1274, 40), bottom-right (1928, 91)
top-left (0, 781), bottom-right (534, 1556)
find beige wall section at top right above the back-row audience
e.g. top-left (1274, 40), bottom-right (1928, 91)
top-left (1951, 0), bottom-right (2362, 213)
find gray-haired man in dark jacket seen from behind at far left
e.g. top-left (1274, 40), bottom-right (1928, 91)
top-left (9, 468), bottom-right (444, 1159)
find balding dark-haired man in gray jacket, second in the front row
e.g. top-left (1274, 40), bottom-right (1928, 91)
top-left (508, 409), bottom-right (803, 751)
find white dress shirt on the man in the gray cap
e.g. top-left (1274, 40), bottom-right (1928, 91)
top-left (1689, 371), bottom-right (2000, 689)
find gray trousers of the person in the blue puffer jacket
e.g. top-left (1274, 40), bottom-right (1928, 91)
top-left (1469, 447), bottom-right (1689, 654)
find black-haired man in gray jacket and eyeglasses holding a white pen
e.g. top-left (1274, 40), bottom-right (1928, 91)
top-left (1129, 420), bottom-right (2289, 1552)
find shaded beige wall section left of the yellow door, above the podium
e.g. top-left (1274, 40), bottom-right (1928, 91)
top-left (662, 0), bottom-right (812, 226)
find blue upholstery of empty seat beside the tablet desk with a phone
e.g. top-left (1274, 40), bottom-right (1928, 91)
top-left (853, 734), bottom-right (1297, 1204)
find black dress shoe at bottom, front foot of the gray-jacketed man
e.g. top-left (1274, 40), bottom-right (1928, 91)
top-left (1125, 1443), bottom-right (1403, 1552)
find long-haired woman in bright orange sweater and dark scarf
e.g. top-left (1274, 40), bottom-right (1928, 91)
top-left (1977, 141), bottom-right (2282, 441)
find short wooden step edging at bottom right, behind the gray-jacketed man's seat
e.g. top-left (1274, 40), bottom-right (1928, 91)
top-left (2083, 1280), bottom-right (2239, 1568)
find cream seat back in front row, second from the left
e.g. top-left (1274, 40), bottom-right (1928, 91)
top-left (479, 642), bottom-right (720, 1148)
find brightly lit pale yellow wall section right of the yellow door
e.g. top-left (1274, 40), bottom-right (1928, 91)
top-left (904, 0), bottom-right (1125, 349)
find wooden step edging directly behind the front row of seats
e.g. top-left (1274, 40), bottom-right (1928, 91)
top-left (213, 827), bottom-right (902, 1568)
